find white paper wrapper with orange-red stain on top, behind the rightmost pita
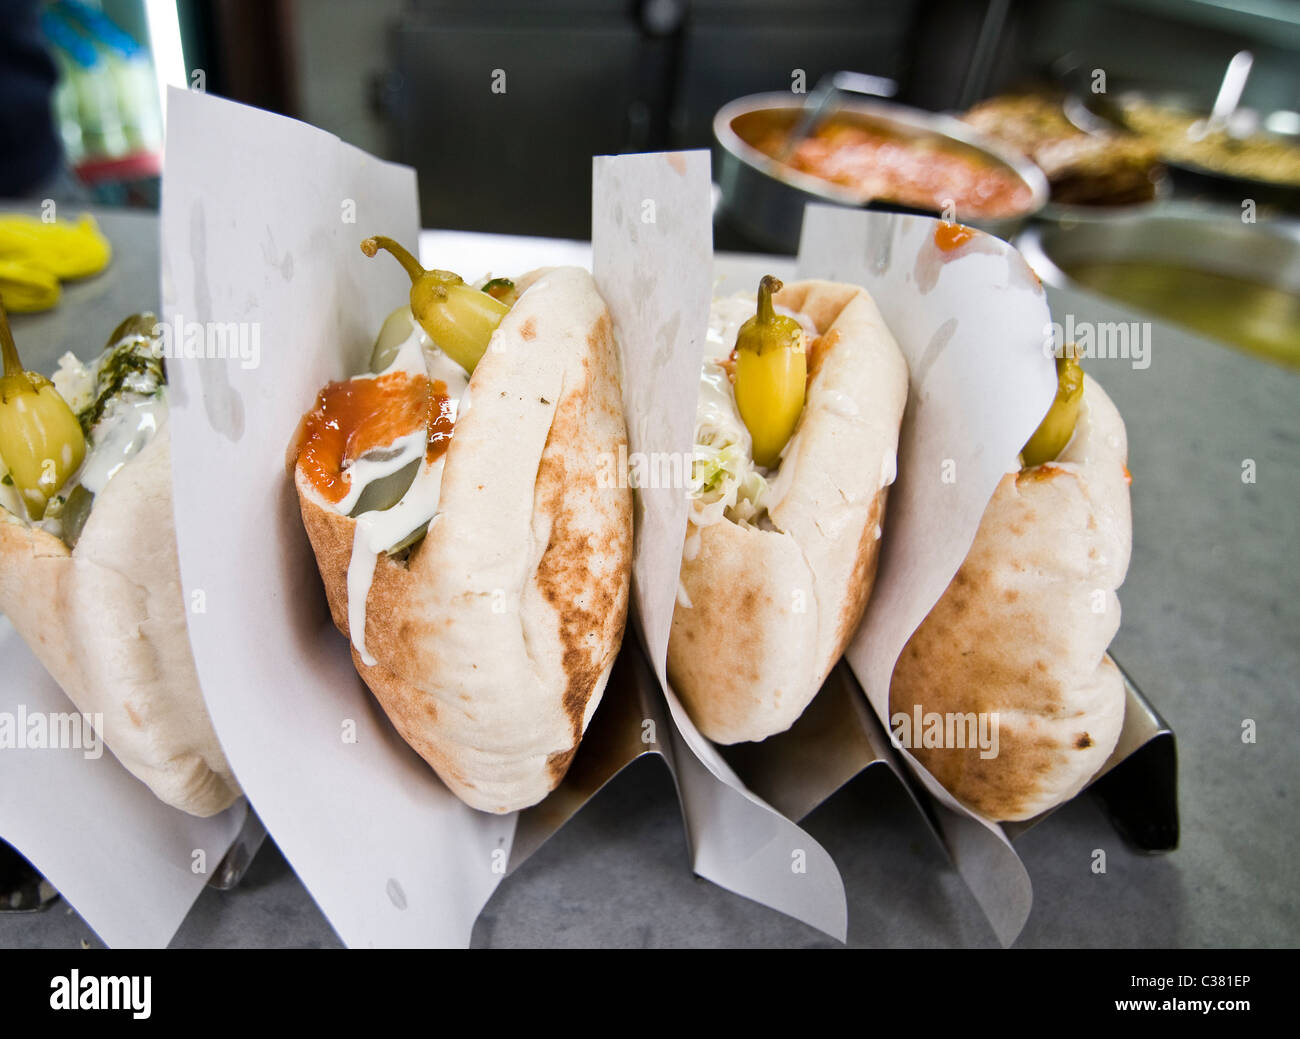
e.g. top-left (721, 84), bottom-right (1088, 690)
top-left (798, 205), bottom-right (1056, 944)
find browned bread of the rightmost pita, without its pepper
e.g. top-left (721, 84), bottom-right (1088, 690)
top-left (889, 377), bottom-right (1132, 821)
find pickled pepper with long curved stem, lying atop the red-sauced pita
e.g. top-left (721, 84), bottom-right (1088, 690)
top-left (361, 235), bottom-right (510, 375)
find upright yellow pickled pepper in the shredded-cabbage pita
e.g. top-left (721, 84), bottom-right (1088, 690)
top-left (735, 274), bottom-right (807, 467)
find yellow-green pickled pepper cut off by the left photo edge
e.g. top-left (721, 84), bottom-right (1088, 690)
top-left (0, 292), bottom-right (86, 520)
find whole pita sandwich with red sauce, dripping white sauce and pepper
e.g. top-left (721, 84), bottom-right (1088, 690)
top-left (289, 238), bottom-right (632, 813)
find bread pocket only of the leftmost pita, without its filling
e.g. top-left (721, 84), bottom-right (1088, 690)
top-left (0, 425), bottom-right (241, 815)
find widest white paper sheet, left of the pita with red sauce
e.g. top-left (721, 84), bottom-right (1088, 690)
top-left (163, 90), bottom-right (515, 945)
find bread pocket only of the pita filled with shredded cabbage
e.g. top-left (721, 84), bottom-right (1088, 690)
top-left (668, 281), bottom-right (907, 744)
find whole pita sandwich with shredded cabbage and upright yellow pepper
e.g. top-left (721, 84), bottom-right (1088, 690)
top-left (668, 277), bottom-right (907, 744)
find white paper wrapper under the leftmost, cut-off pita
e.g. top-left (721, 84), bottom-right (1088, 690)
top-left (0, 616), bottom-right (248, 948)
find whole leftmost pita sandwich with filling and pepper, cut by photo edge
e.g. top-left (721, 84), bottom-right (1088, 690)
top-left (0, 304), bottom-right (241, 815)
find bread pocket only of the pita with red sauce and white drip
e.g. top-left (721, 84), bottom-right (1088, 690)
top-left (295, 268), bottom-right (632, 813)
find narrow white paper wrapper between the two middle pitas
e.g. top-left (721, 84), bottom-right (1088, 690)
top-left (592, 152), bottom-right (848, 940)
